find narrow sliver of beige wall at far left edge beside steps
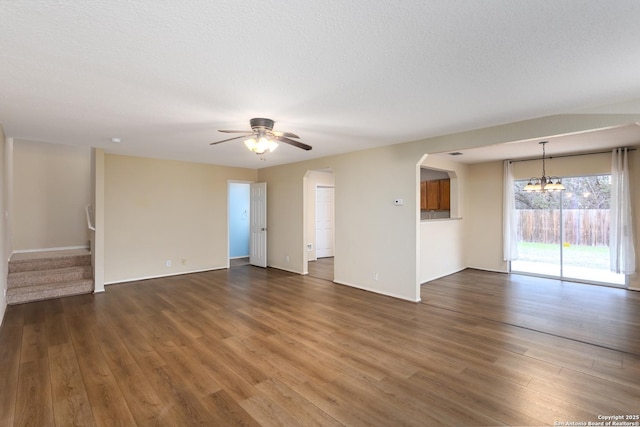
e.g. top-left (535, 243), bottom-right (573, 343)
top-left (0, 125), bottom-right (10, 327)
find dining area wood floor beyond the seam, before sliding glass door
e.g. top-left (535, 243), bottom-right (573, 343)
top-left (421, 269), bottom-right (640, 356)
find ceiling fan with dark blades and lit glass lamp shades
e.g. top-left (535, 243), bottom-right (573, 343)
top-left (210, 118), bottom-right (311, 154)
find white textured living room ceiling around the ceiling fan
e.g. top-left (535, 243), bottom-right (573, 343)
top-left (0, 0), bottom-right (640, 168)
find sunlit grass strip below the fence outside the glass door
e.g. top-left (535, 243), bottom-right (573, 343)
top-left (518, 242), bottom-right (609, 270)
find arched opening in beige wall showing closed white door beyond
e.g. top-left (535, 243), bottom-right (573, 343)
top-left (305, 170), bottom-right (335, 281)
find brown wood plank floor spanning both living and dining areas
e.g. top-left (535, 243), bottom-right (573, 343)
top-left (0, 266), bottom-right (640, 426)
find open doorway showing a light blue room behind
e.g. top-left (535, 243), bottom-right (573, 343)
top-left (229, 182), bottom-right (251, 267)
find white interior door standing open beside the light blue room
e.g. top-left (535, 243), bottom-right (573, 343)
top-left (249, 182), bottom-right (267, 267)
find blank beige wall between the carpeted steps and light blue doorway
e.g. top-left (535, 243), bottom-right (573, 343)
top-left (104, 154), bottom-right (257, 284)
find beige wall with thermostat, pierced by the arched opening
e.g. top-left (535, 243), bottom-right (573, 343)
top-left (258, 146), bottom-right (421, 301)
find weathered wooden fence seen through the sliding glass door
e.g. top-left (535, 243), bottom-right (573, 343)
top-left (516, 209), bottom-right (610, 246)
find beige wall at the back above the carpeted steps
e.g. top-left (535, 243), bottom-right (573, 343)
top-left (12, 140), bottom-right (91, 251)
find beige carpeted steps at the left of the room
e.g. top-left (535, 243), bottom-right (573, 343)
top-left (7, 250), bottom-right (93, 304)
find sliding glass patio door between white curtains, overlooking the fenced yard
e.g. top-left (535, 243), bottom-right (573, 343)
top-left (511, 175), bottom-right (625, 286)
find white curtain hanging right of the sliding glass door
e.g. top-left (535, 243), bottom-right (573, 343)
top-left (609, 148), bottom-right (636, 274)
